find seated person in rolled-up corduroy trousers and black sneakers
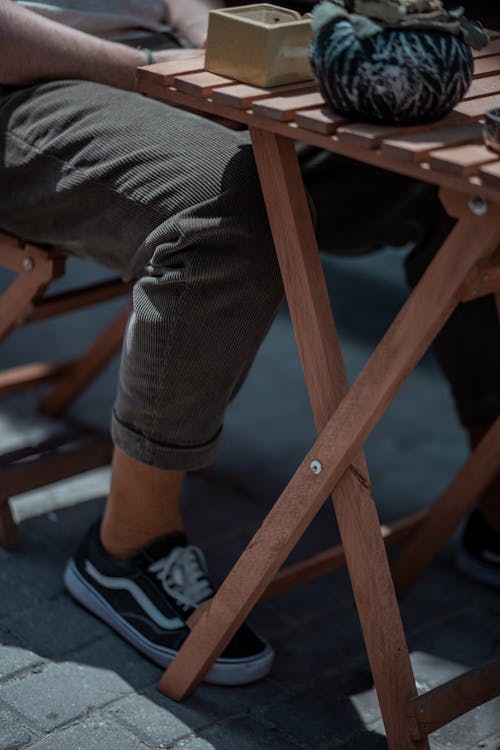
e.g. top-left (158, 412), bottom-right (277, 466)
top-left (0, 0), bottom-right (500, 685)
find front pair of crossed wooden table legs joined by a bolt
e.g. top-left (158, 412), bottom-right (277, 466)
top-left (159, 129), bottom-right (500, 750)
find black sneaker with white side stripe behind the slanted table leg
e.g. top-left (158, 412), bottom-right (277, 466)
top-left (64, 524), bottom-right (274, 685)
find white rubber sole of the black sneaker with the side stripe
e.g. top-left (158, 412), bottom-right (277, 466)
top-left (64, 560), bottom-right (274, 685)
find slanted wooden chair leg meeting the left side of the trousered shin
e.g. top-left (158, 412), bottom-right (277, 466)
top-left (39, 307), bottom-right (130, 417)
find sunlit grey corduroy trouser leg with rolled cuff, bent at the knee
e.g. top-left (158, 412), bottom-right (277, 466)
top-left (0, 81), bottom-right (282, 469)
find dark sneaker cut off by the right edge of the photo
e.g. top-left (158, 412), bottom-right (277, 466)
top-left (456, 510), bottom-right (500, 589)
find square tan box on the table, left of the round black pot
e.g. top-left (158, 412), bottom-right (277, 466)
top-left (205, 3), bottom-right (314, 87)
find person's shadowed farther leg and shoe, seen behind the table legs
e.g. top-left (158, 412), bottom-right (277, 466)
top-left (300, 148), bottom-right (500, 587)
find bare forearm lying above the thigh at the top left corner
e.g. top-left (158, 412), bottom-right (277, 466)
top-left (0, 0), bottom-right (145, 89)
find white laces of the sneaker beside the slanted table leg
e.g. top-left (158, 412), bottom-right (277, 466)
top-left (148, 545), bottom-right (214, 608)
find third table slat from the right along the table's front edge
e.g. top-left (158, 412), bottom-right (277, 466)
top-left (381, 123), bottom-right (483, 161)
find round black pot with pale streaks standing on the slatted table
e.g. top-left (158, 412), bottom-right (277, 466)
top-left (310, 20), bottom-right (473, 125)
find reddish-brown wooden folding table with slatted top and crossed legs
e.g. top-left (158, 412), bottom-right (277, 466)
top-left (138, 39), bottom-right (500, 750)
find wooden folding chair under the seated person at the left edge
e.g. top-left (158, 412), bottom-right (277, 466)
top-left (0, 233), bottom-right (132, 549)
